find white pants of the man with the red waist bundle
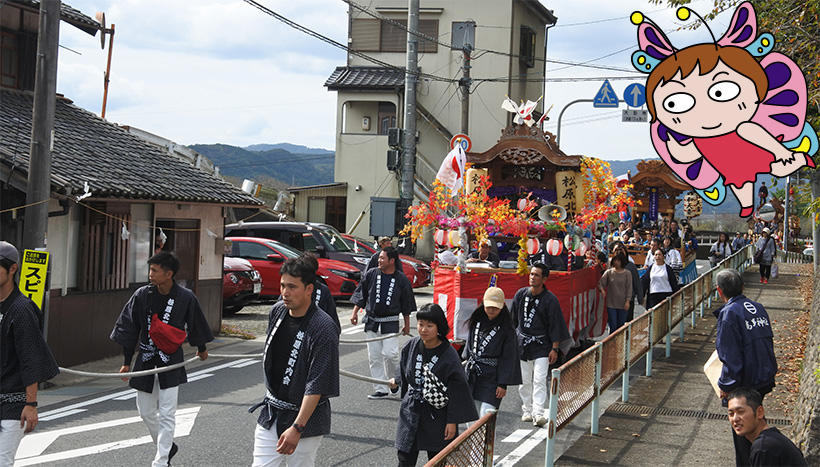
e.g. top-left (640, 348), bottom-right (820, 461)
top-left (137, 375), bottom-right (179, 467)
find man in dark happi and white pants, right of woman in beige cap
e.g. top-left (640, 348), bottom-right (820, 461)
top-left (512, 263), bottom-right (570, 426)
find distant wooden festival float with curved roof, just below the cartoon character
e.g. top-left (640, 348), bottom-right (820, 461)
top-left (630, 159), bottom-right (703, 284)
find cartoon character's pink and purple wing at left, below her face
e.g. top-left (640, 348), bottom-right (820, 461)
top-left (650, 121), bottom-right (726, 206)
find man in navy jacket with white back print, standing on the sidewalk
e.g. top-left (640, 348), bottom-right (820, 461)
top-left (714, 269), bottom-right (777, 466)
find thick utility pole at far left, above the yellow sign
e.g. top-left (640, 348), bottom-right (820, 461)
top-left (22, 0), bottom-right (60, 254)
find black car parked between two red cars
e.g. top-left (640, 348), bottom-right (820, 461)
top-left (225, 222), bottom-right (370, 271)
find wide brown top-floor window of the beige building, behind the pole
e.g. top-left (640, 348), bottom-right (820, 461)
top-left (350, 19), bottom-right (438, 53)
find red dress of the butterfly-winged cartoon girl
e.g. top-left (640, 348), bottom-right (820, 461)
top-left (693, 131), bottom-right (774, 188)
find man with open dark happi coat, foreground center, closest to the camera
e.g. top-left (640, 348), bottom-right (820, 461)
top-left (250, 258), bottom-right (339, 466)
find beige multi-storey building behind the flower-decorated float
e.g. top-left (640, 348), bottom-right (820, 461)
top-left (325, 0), bottom-right (557, 254)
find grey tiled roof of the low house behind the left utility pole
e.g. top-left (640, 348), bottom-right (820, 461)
top-left (0, 89), bottom-right (262, 205)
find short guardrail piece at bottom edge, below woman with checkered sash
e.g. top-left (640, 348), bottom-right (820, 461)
top-left (424, 411), bottom-right (497, 467)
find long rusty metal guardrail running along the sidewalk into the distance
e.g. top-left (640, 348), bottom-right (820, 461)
top-left (544, 245), bottom-right (756, 467)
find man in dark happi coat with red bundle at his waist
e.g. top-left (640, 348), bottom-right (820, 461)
top-left (111, 251), bottom-right (214, 467)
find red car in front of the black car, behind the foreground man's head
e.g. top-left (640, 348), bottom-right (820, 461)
top-left (225, 237), bottom-right (362, 299)
